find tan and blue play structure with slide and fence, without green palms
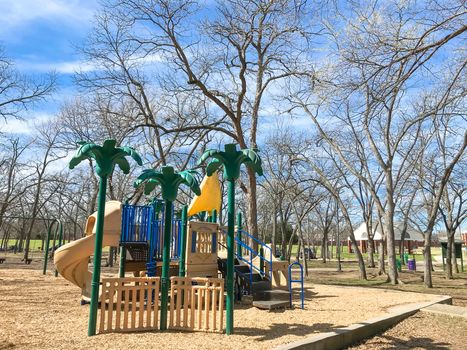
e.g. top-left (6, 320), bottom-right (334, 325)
top-left (54, 197), bottom-right (300, 333)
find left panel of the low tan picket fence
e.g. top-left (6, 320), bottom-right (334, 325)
top-left (99, 277), bottom-right (160, 333)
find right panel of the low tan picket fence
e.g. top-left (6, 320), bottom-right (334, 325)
top-left (169, 277), bottom-right (224, 332)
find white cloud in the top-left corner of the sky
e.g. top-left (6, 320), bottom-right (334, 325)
top-left (0, 0), bottom-right (97, 33)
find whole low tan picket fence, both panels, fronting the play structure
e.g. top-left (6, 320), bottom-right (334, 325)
top-left (99, 277), bottom-right (224, 333)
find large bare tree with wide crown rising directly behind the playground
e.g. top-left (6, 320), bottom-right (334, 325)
top-left (80, 0), bottom-right (320, 246)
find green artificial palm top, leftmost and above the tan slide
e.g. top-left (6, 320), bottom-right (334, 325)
top-left (69, 139), bottom-right (143, 177)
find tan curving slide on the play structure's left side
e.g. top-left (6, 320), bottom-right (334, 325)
top-left (54, 201), bottom-right (122, 297)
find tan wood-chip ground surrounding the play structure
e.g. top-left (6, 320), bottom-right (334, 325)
top-left (0, 262), bottom-right (435, 349)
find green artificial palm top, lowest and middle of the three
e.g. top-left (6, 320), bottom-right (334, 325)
top-left (134, 166), bottom-right (201, 202)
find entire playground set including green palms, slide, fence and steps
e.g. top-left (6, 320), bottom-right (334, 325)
top-left (54, 140), bottom-right (303, 335)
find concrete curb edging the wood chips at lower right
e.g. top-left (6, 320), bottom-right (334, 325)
top-left (274, 295), bottom-right (452, 350)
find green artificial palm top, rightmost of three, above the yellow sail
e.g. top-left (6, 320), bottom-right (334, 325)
top-left (198, 143), bottom-right (263, 180)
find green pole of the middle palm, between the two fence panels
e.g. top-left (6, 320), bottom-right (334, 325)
top-left (160, 200), bottom-right (172, 331)
